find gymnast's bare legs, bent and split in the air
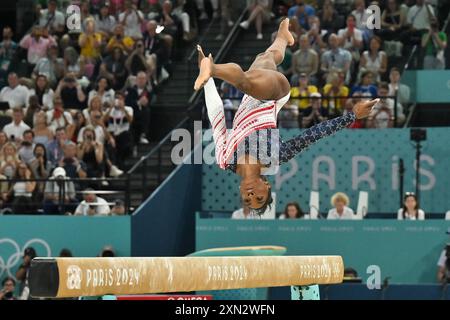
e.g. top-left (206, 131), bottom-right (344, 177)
top-left (194, 19), bottom-right (294, 100)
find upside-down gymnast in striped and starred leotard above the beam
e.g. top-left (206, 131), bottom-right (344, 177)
top-left (194, 19), bottom-right (378, 215)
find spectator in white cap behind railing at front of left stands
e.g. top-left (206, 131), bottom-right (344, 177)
top-left (44, 167), bottom-right (78, 215)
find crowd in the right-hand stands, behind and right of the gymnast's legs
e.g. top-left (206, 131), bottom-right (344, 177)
top-left (221, 0), bottom-right (448, 128)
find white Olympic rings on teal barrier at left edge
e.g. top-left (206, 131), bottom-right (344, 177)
top-left (0, 238), bottom-right (52, 279)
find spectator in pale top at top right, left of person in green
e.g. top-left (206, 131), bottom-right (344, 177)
top-left (406, 0), bottom-right (435, 43)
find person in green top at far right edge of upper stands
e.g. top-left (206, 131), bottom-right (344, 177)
top-left (422, 18), bottom-right (447, 69)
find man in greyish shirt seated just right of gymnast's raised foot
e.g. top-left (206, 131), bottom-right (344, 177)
top-left (291, 34), bottom-right (319, 84)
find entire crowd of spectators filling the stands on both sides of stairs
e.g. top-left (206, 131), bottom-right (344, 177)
top-left (0, 0), bottom-right (447, 214)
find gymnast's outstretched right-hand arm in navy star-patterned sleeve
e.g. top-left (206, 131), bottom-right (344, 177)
top-left (279, 99), bottom-right (379, 164)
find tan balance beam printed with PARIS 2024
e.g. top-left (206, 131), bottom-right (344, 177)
top-left (29, 256), bottom-right (344, 298)
